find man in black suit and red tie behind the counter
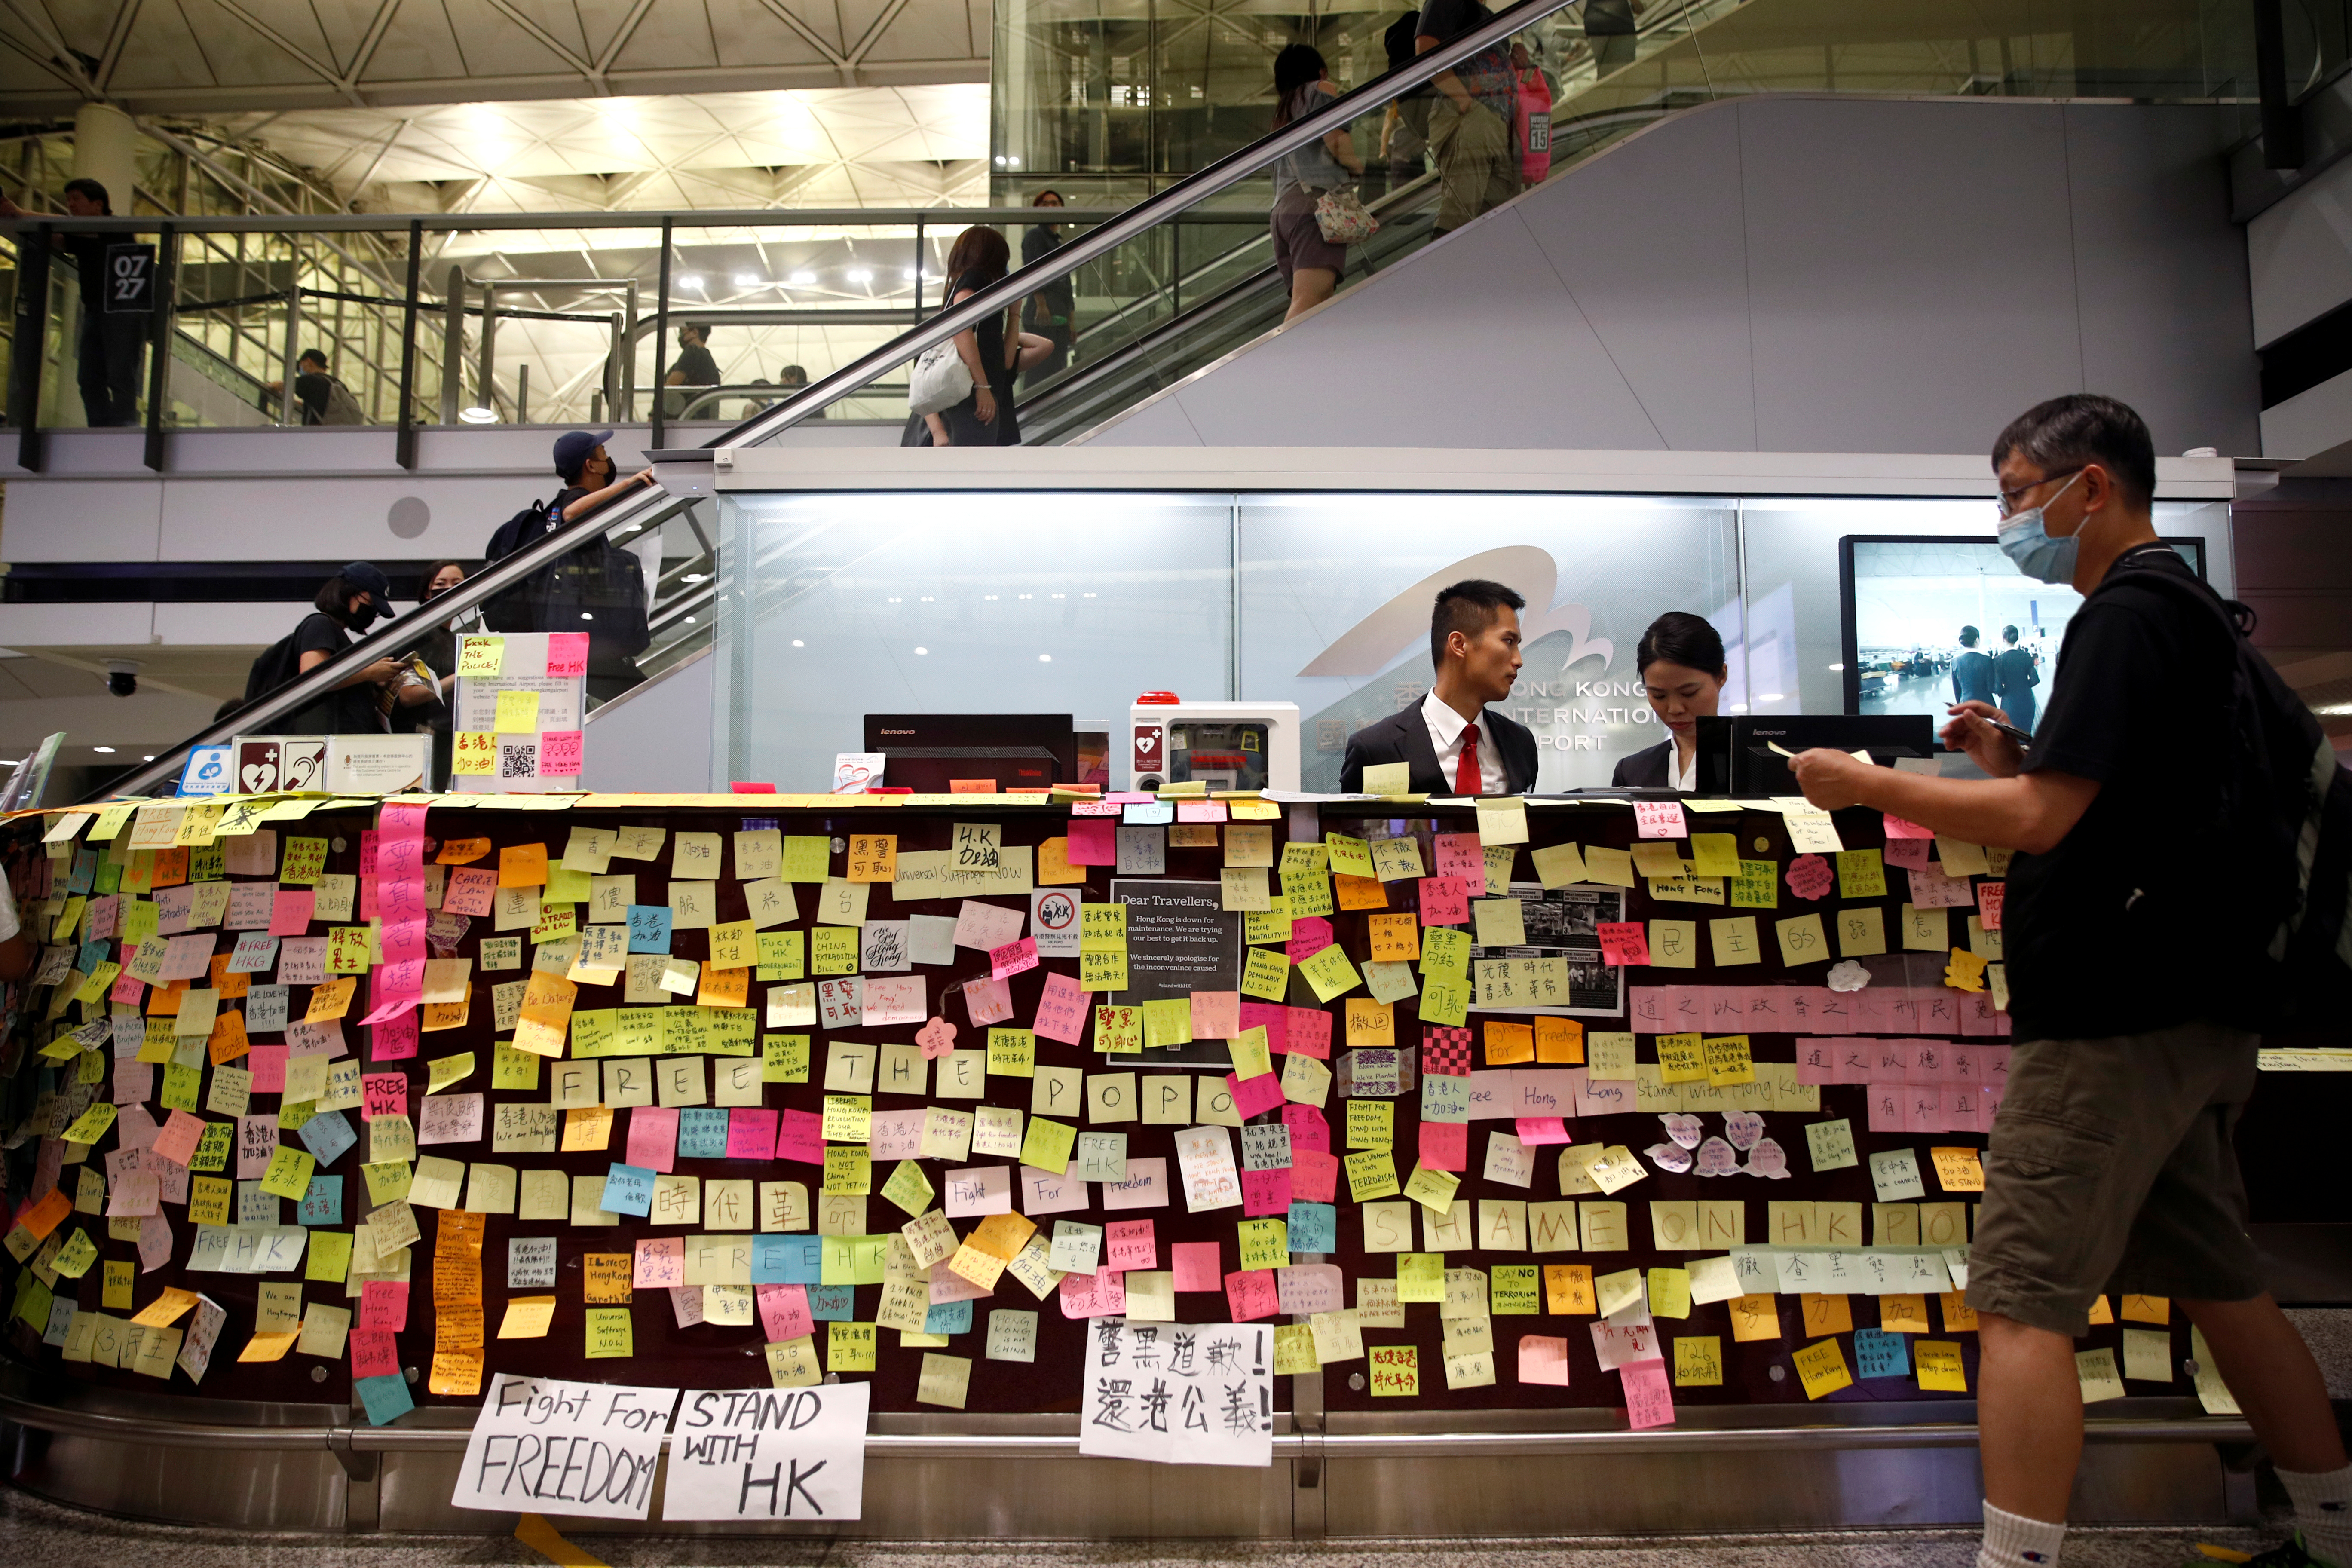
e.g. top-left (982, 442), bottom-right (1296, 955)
top-left (1338, 578), bottom-right (1536, 795)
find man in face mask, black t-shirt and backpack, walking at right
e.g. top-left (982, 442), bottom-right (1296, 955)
top-left (1792, 395), bottom-right (2352, 1568)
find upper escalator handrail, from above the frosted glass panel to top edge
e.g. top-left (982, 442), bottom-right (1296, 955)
top-left (703, 0), bottom-right (1576, 449)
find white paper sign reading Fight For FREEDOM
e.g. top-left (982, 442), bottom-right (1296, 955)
top-left (449, 1373), bottom-right (677, 1519)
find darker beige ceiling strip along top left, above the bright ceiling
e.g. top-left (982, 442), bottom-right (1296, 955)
top-left (0, 0), bottom-right (990, 115)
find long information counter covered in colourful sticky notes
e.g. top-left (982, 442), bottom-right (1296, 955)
top-left (0, 795), bottom-right (2251, 1537)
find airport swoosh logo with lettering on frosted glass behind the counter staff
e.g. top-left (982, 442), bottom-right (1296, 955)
top-left (1298, 545), bottom-right (1658, 790)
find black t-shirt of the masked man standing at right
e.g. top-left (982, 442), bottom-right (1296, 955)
top-left (2002, 545), bottom-right (2256, 1041)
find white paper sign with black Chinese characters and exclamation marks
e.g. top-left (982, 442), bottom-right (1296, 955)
top-left (1077, 1317), bottom-right (1275, 1467)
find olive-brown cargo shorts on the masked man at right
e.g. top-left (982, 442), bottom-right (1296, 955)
top-left (1966, 1023), bottom-right (2265, 1338)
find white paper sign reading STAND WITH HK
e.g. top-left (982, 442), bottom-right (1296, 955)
top-left (661, 1382), bottom-right (873, 1519)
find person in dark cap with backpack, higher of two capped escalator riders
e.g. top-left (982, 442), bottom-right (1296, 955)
top-left (482, 430), bottom-right (654, 701)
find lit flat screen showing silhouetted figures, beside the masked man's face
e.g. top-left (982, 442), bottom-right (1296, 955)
top-left (1837, 534), bottom-right (2206, 731)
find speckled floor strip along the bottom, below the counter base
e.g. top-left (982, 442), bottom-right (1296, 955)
top-left (0, 1488), bottom-right (2267, 1568)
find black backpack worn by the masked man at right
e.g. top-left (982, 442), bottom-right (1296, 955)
top-left (2122, 567), bottom-right (2352, 1030)
